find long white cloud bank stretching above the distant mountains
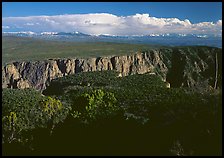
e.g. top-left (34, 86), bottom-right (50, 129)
top-left (2, 13), bottom-right (222, 35)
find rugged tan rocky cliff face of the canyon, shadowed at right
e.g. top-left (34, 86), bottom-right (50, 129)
top-left (2, 47), bottom-right (222, 91)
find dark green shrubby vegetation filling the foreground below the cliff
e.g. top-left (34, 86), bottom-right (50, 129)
top-left (2, 71), bottom-right (222, 155)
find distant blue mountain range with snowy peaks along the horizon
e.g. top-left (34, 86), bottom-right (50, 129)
top-left (2, 31), bottom-right (222, 48)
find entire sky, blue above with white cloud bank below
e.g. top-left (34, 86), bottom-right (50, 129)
top-left (2, 2), bottom-right (222, 35)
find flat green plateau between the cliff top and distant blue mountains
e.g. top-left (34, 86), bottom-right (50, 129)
top-left (2, 36), bottom-right (164, 65)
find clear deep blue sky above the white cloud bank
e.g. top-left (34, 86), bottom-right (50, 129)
top-left (2, 2), bottom-right (222, 23)
